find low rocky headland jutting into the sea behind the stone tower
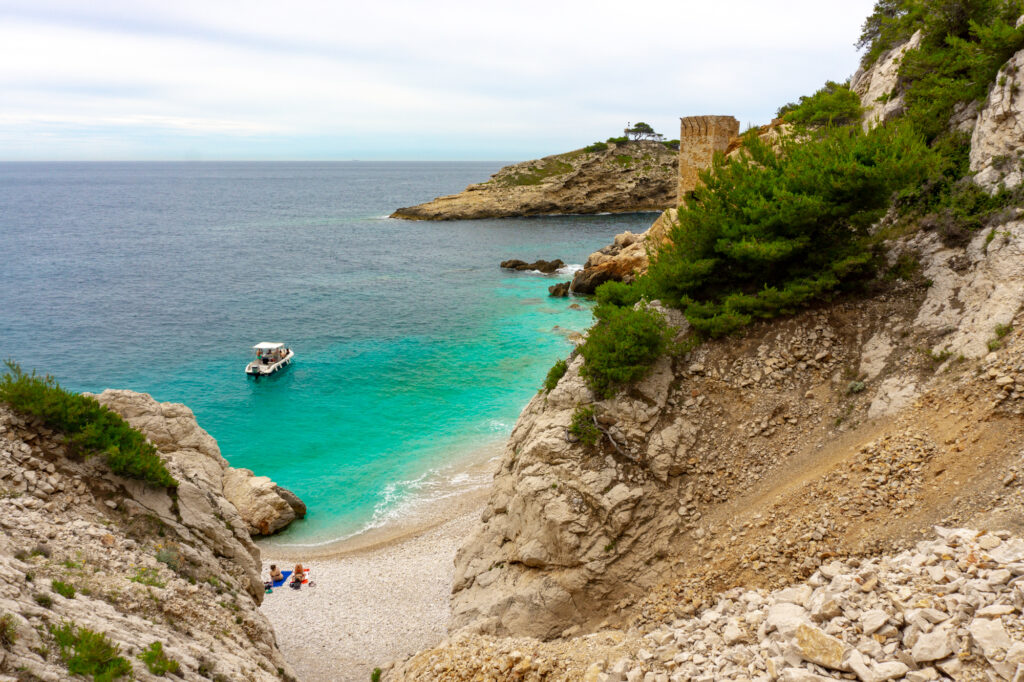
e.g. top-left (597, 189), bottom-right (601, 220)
top-left (391, 141), bottom-right (678, 220)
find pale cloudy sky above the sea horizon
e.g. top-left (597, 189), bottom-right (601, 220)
top-left (0, 0), bottom-right (873, 161)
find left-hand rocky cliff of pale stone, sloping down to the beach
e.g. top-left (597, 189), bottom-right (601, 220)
top-left (0, 391), bottom-right (303, 682)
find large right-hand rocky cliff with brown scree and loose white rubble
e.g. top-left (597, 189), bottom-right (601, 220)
top-left (391, 29), bottom-right (1024, 682)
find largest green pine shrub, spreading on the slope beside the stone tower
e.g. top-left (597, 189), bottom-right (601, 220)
top-left (647, 126), bottom-right (934, 337)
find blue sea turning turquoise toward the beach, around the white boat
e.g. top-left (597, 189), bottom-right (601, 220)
top-left (0, 161), bottom-right (653, 547)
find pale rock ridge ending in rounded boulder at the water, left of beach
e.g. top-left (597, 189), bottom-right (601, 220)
top-left (96, 389), bottom-right (306, 536)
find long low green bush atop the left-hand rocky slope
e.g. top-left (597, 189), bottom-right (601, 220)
top-left (0, 360), bottom-right (178, 487)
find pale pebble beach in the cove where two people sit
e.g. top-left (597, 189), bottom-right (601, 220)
top-left (261, 486), bottom-right (489, 682)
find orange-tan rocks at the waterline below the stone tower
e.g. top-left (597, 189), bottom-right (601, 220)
top-left (570, 209), bottom-right (677, 294)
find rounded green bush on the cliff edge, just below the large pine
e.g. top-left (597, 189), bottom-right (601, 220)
top-left (580, 303), bottom-right (669, 397)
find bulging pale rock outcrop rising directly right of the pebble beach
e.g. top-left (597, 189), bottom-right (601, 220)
top-left (453, 348), bottom-right (694, 638)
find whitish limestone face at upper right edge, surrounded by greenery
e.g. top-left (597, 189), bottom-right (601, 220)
top-left (971, 50), bottom-right (1024, 191)
